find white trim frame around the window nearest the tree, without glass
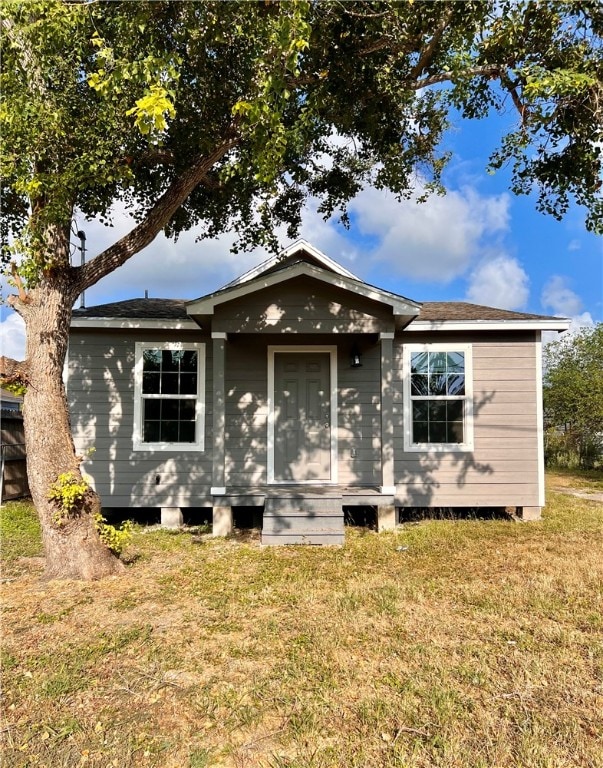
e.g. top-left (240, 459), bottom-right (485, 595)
top-left (132, 341), bottom-right (206, 453)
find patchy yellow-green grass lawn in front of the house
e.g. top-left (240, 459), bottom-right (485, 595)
top-left (2, 468), bottom-right (603, 768)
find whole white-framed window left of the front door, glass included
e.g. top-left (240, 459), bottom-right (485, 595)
top-left (134, 342), bottom-right (205, 451)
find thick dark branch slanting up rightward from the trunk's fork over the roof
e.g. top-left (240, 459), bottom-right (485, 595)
top-left (76, 138), bottom-right (239, 293)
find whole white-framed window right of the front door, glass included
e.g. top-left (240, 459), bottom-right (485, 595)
top-left (404, 344), bottom-right (473, 451)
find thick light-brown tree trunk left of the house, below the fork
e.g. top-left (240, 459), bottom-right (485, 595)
top-left (19, 278), bottom-right (124, 579)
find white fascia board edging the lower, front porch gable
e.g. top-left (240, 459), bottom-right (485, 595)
top-left (186, 263), bottom-right (420, 315)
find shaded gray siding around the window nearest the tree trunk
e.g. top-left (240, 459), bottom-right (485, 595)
top-left (67, 329), bottom-right (212, 507)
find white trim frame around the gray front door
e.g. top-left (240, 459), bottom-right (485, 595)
top-left (267, 344), bottom-right (338, 485)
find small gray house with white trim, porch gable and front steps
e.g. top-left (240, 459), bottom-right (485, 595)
top-left (68, 241), bottom-right (569, 543)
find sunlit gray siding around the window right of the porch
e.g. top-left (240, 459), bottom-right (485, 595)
top-left (394, 332), bottom-right (540, 507)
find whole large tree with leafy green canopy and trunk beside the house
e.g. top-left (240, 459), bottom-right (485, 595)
top-left (0, 0), bottom-right (603, 577)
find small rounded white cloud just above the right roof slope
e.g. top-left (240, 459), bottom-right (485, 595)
top-left (467, 254), bottom-right (530, 309)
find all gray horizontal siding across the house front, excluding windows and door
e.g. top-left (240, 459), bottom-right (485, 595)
top-left (68, 320), bottom-right (539, 507)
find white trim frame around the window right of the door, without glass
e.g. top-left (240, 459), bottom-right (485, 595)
top-left (402, 343), bottom-right (474, 454)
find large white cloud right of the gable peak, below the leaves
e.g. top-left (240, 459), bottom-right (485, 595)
top-left (350, 187), bottom-right (509, 283)
